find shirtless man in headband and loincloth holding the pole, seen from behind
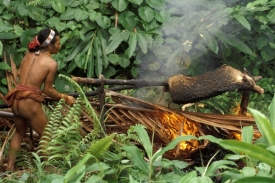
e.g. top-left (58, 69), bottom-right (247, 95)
top-left (6, 28), bottom-right (74, 170)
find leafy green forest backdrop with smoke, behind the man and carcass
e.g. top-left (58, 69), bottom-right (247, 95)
top-left (0, 0), bottom-right (275, 113)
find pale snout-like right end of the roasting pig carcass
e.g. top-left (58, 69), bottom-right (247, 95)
top-left (241, 69), bottom-right (264, 94)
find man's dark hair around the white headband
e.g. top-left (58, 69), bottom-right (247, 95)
top-left (28, 28), bottom-right (59, 52)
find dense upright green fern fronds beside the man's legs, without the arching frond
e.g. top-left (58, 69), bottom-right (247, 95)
top-left (40, 100), bottom-right (82, 163)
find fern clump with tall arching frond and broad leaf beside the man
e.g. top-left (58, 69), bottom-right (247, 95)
top-left (35, 75), bottom-right (110, 172)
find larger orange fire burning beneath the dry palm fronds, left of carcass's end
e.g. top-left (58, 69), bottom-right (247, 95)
top-left (158, 112), bottom-right (199, 152)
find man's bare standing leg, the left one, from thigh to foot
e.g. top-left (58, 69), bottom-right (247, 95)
top-left (7, 116), bottom-right (27, 171)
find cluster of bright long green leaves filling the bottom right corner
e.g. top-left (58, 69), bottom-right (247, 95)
top-left (209, 96), bottom-right (275, 183)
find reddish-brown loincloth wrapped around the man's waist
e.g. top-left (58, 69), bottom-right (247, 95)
top-left (5, 84), bottom-right (44, 107)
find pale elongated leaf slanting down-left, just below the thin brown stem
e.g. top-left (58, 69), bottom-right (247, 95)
top-left (106, 32), bottom-right (130, 54)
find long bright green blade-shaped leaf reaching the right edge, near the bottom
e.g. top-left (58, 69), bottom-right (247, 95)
top-left (218, 140), bottom-right (275, 166)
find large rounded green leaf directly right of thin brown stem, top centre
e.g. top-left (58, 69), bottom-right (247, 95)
top-left (118, 11), bottom-right (137, 30)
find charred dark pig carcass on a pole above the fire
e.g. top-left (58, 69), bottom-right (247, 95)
top-left (166, 65), bottom-right (264, 104)
